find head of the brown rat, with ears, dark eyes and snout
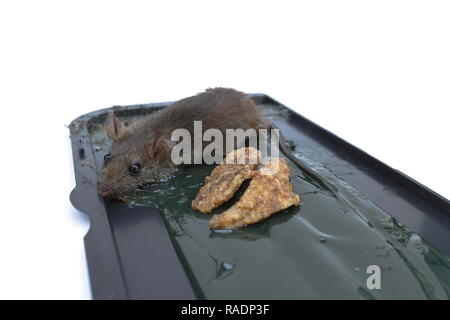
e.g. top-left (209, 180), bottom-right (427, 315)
top-left (97, 112), bottom-right (174, 197)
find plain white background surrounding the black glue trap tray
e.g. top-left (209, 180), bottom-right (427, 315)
top-left (0, 0), bottom-right (450, 299)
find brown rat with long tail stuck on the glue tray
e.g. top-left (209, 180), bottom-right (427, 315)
top-left (97, 88), bottom-right (330, 199)
